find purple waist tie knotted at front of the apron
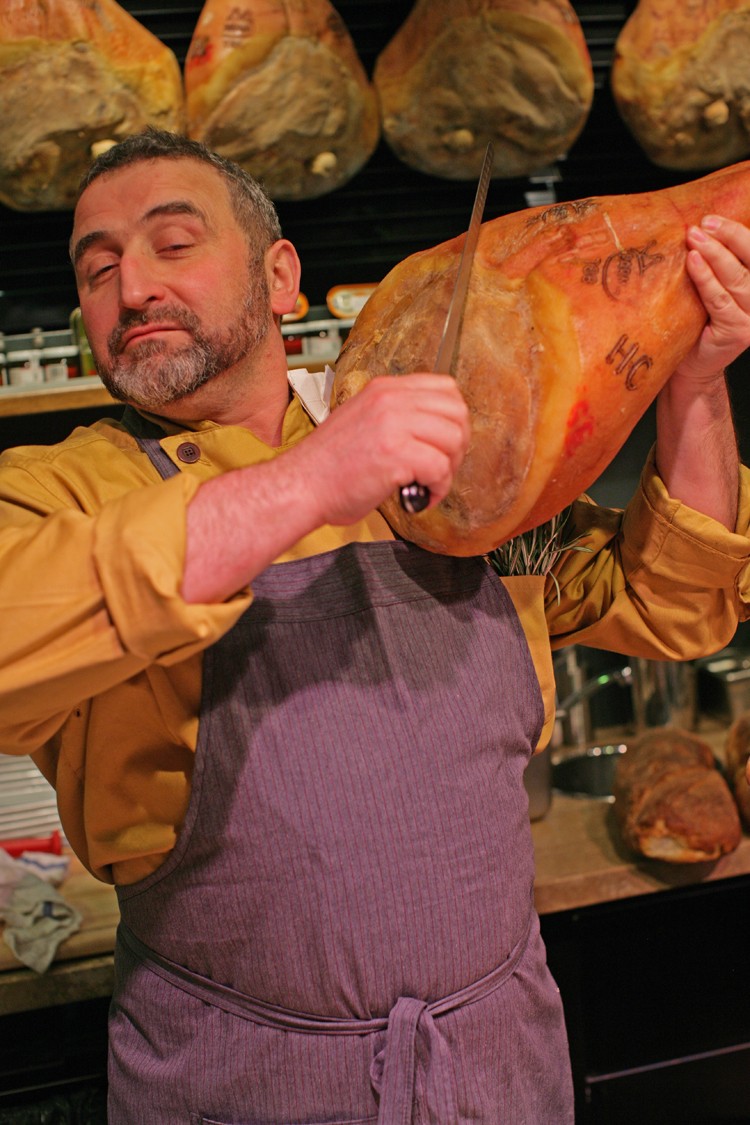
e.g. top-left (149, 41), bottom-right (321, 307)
top-left (117, 910), bottom-right (533, 1125)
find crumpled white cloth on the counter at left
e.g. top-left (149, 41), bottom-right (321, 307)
top-left (0, 847), bottom-right (83, 973)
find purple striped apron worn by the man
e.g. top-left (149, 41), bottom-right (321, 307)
top-left (109, 423), bottom-right (572, 1125)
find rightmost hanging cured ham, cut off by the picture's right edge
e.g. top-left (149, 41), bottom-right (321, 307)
top-left (612, 0), bottom-right (750, 170)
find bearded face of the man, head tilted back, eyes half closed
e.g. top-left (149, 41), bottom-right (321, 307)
top-left (73, 159), bottom-right (272, 413)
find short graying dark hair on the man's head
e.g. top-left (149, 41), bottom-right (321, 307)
top-left (79, 126), bottom-right (281, 257)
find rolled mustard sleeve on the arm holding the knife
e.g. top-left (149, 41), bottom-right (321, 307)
top-left (0, 450), bottom-right (252, 753)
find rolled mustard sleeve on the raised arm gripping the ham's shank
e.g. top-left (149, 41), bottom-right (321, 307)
top-left (545, 456), bottom-right (750, 659)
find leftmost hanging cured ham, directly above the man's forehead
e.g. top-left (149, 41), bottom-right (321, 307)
top-left (0, 0), bottom-right (184, 210)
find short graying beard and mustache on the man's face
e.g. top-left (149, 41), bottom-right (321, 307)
top-left (94, 278), bottom-right (272, 413)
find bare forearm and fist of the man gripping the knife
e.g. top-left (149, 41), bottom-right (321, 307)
top-left (181, 374), bottom-right (470, 603)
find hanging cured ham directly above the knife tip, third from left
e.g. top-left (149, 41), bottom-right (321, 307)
top-left (372, 0), bottom-right (594, 180)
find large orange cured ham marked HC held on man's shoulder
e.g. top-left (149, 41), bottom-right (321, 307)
top-left (334, 162), bottom-right (750, 555)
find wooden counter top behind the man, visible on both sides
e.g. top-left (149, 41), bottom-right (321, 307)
top-left (0, 733), bottom-right (750, 1015)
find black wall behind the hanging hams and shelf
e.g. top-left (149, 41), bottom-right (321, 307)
top-left (0, 0), bottom-right (750, 492)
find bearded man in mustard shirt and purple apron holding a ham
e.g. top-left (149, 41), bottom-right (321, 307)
top-left (0, 131), bottom-right (750, 1125)
